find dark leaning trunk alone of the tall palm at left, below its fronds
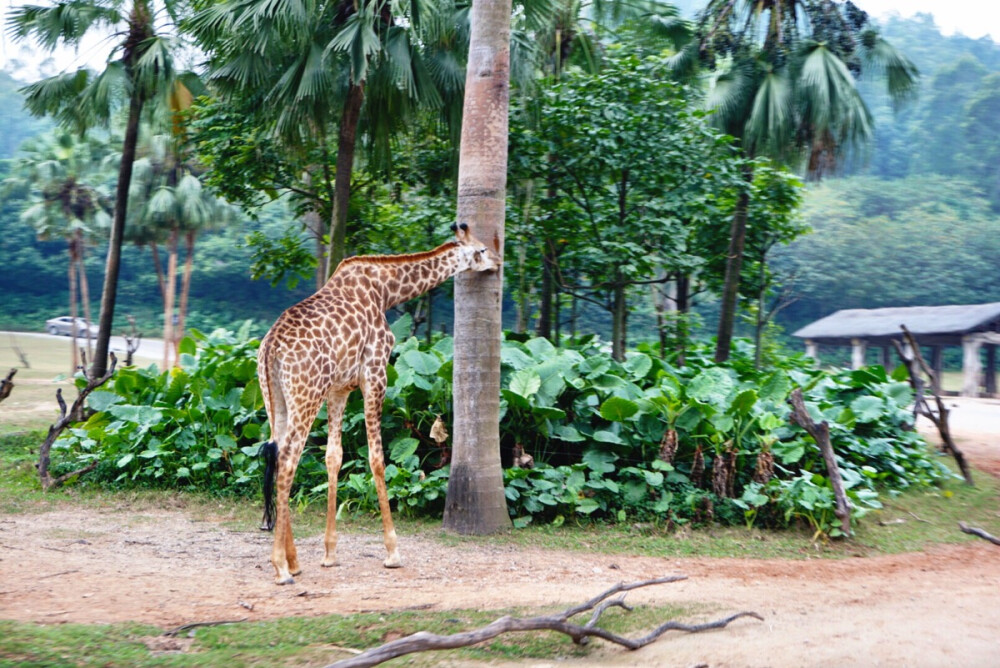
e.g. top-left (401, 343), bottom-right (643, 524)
top-left (90, 91), bottom-right (143, 378)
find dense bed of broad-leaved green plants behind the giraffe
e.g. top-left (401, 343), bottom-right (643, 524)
top-left (58, 323), bottom-right (947, 535)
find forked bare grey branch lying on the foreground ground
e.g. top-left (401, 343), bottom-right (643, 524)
top-left (327, 575), bottom-right (764, 668)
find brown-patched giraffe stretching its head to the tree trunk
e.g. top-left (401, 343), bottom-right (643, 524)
top-left (257, 223), bottom-right (500, 584)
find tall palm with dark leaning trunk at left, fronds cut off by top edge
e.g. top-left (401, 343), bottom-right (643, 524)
top-left (7, 0), bottom-right (199, 377)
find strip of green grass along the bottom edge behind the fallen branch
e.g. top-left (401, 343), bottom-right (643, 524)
top-left (0, 605), bottom-right (692, 668)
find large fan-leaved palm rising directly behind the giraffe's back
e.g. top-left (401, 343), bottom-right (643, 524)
top-left (187, 0), bottom-right (462, 275)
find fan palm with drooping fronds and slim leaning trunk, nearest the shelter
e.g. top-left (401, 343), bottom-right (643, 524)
top-left (674, 0), bottom-right (917, 362)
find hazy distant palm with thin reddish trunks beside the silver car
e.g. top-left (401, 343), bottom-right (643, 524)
top-left (4, 128), bottom-right (110, 373)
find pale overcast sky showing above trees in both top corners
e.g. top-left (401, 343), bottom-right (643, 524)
top-left (0, 0), bottom-right (1000, 80)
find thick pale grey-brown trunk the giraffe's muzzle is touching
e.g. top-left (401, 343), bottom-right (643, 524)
top-left (444, 0), bottom-right (511, 535)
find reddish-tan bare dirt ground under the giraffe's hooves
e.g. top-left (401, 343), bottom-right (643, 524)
top-left (0, 400), bottom-right (1000, 667)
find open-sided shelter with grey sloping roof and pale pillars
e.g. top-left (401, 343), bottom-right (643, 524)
top-left (793, 302), bottom-right (1000, 396)
